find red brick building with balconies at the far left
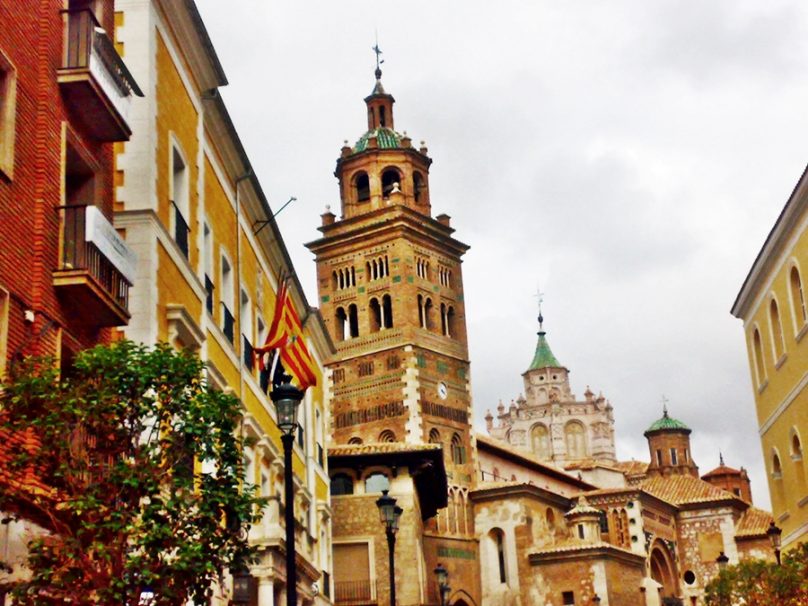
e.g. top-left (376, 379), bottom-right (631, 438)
top-left (0, 0), bottom-right (140, 378)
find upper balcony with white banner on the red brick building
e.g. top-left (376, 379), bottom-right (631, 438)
top-left (56, 9), bottom-right (143, 141)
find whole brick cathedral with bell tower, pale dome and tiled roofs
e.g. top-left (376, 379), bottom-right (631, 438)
top-left (318, 65), bottom-right (773, 606)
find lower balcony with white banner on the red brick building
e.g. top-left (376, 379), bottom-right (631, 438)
top-left (53, 206), bottom-right (137, 326)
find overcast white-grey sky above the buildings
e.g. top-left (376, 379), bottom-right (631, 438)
top-left (198, 0), bottom-right (808, 507)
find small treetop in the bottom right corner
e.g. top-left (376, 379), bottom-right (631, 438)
top-left (707, 543), bottom-right (808, 606)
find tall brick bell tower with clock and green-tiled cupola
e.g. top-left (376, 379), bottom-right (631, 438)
top-left (307, 59), bottom-right (476, 572)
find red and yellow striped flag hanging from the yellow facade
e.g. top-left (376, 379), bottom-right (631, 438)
top-left (255, 278), bottom-right (317, 391)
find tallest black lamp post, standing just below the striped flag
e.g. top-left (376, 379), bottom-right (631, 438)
top-left (269, 375), bottom-right (303, 606)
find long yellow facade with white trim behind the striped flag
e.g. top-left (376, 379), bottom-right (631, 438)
top-left (115, 0), bottom-right (333, 606)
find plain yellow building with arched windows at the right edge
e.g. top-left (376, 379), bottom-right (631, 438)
top-left (732, 164), bottom-right (808, 550)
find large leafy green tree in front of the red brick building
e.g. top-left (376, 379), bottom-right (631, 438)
top-left (0, 341), bottom-right (264, 605)
